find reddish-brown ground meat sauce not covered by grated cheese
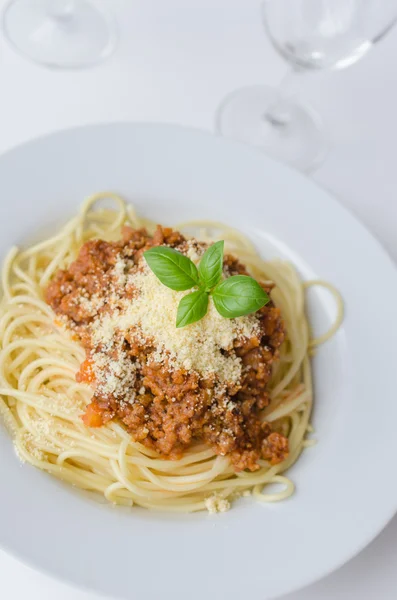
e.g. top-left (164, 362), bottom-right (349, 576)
top-left (46, 226), bottom-right (288, 471)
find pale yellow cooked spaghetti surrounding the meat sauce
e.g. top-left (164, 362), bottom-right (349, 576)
top-left (0, 193), bottom-right (343, 512)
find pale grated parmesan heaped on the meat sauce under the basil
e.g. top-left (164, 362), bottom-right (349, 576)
top-left (89, 260), bottom-right (259, 386)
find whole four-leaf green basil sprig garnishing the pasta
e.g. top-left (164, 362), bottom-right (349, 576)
top-left (144, 241), bottom-right (270, 327)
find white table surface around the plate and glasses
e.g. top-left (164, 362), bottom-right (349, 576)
top-left (0, 0), bottom-right (397, 600)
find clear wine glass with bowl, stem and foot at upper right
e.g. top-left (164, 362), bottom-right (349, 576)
top-left (216, 0), bottom-right (397, 171)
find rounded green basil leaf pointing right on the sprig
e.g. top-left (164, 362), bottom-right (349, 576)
top-left (212, 275), bottom-right (270, 319)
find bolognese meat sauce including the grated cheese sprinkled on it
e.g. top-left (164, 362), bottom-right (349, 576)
top-left (46, 226), bottom-right (288, 471)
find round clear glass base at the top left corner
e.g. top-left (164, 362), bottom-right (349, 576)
top-left (3, 0), bottom-right (117, 69)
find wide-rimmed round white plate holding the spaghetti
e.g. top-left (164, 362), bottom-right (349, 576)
top-left (0, 124), bottom-right (397, 600)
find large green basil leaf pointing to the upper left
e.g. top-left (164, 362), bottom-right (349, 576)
top-left (143, 246), bottom-right (199, 292)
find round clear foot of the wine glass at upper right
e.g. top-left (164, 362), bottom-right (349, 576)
top-left (216, 86), bottom-right (328, 172)
